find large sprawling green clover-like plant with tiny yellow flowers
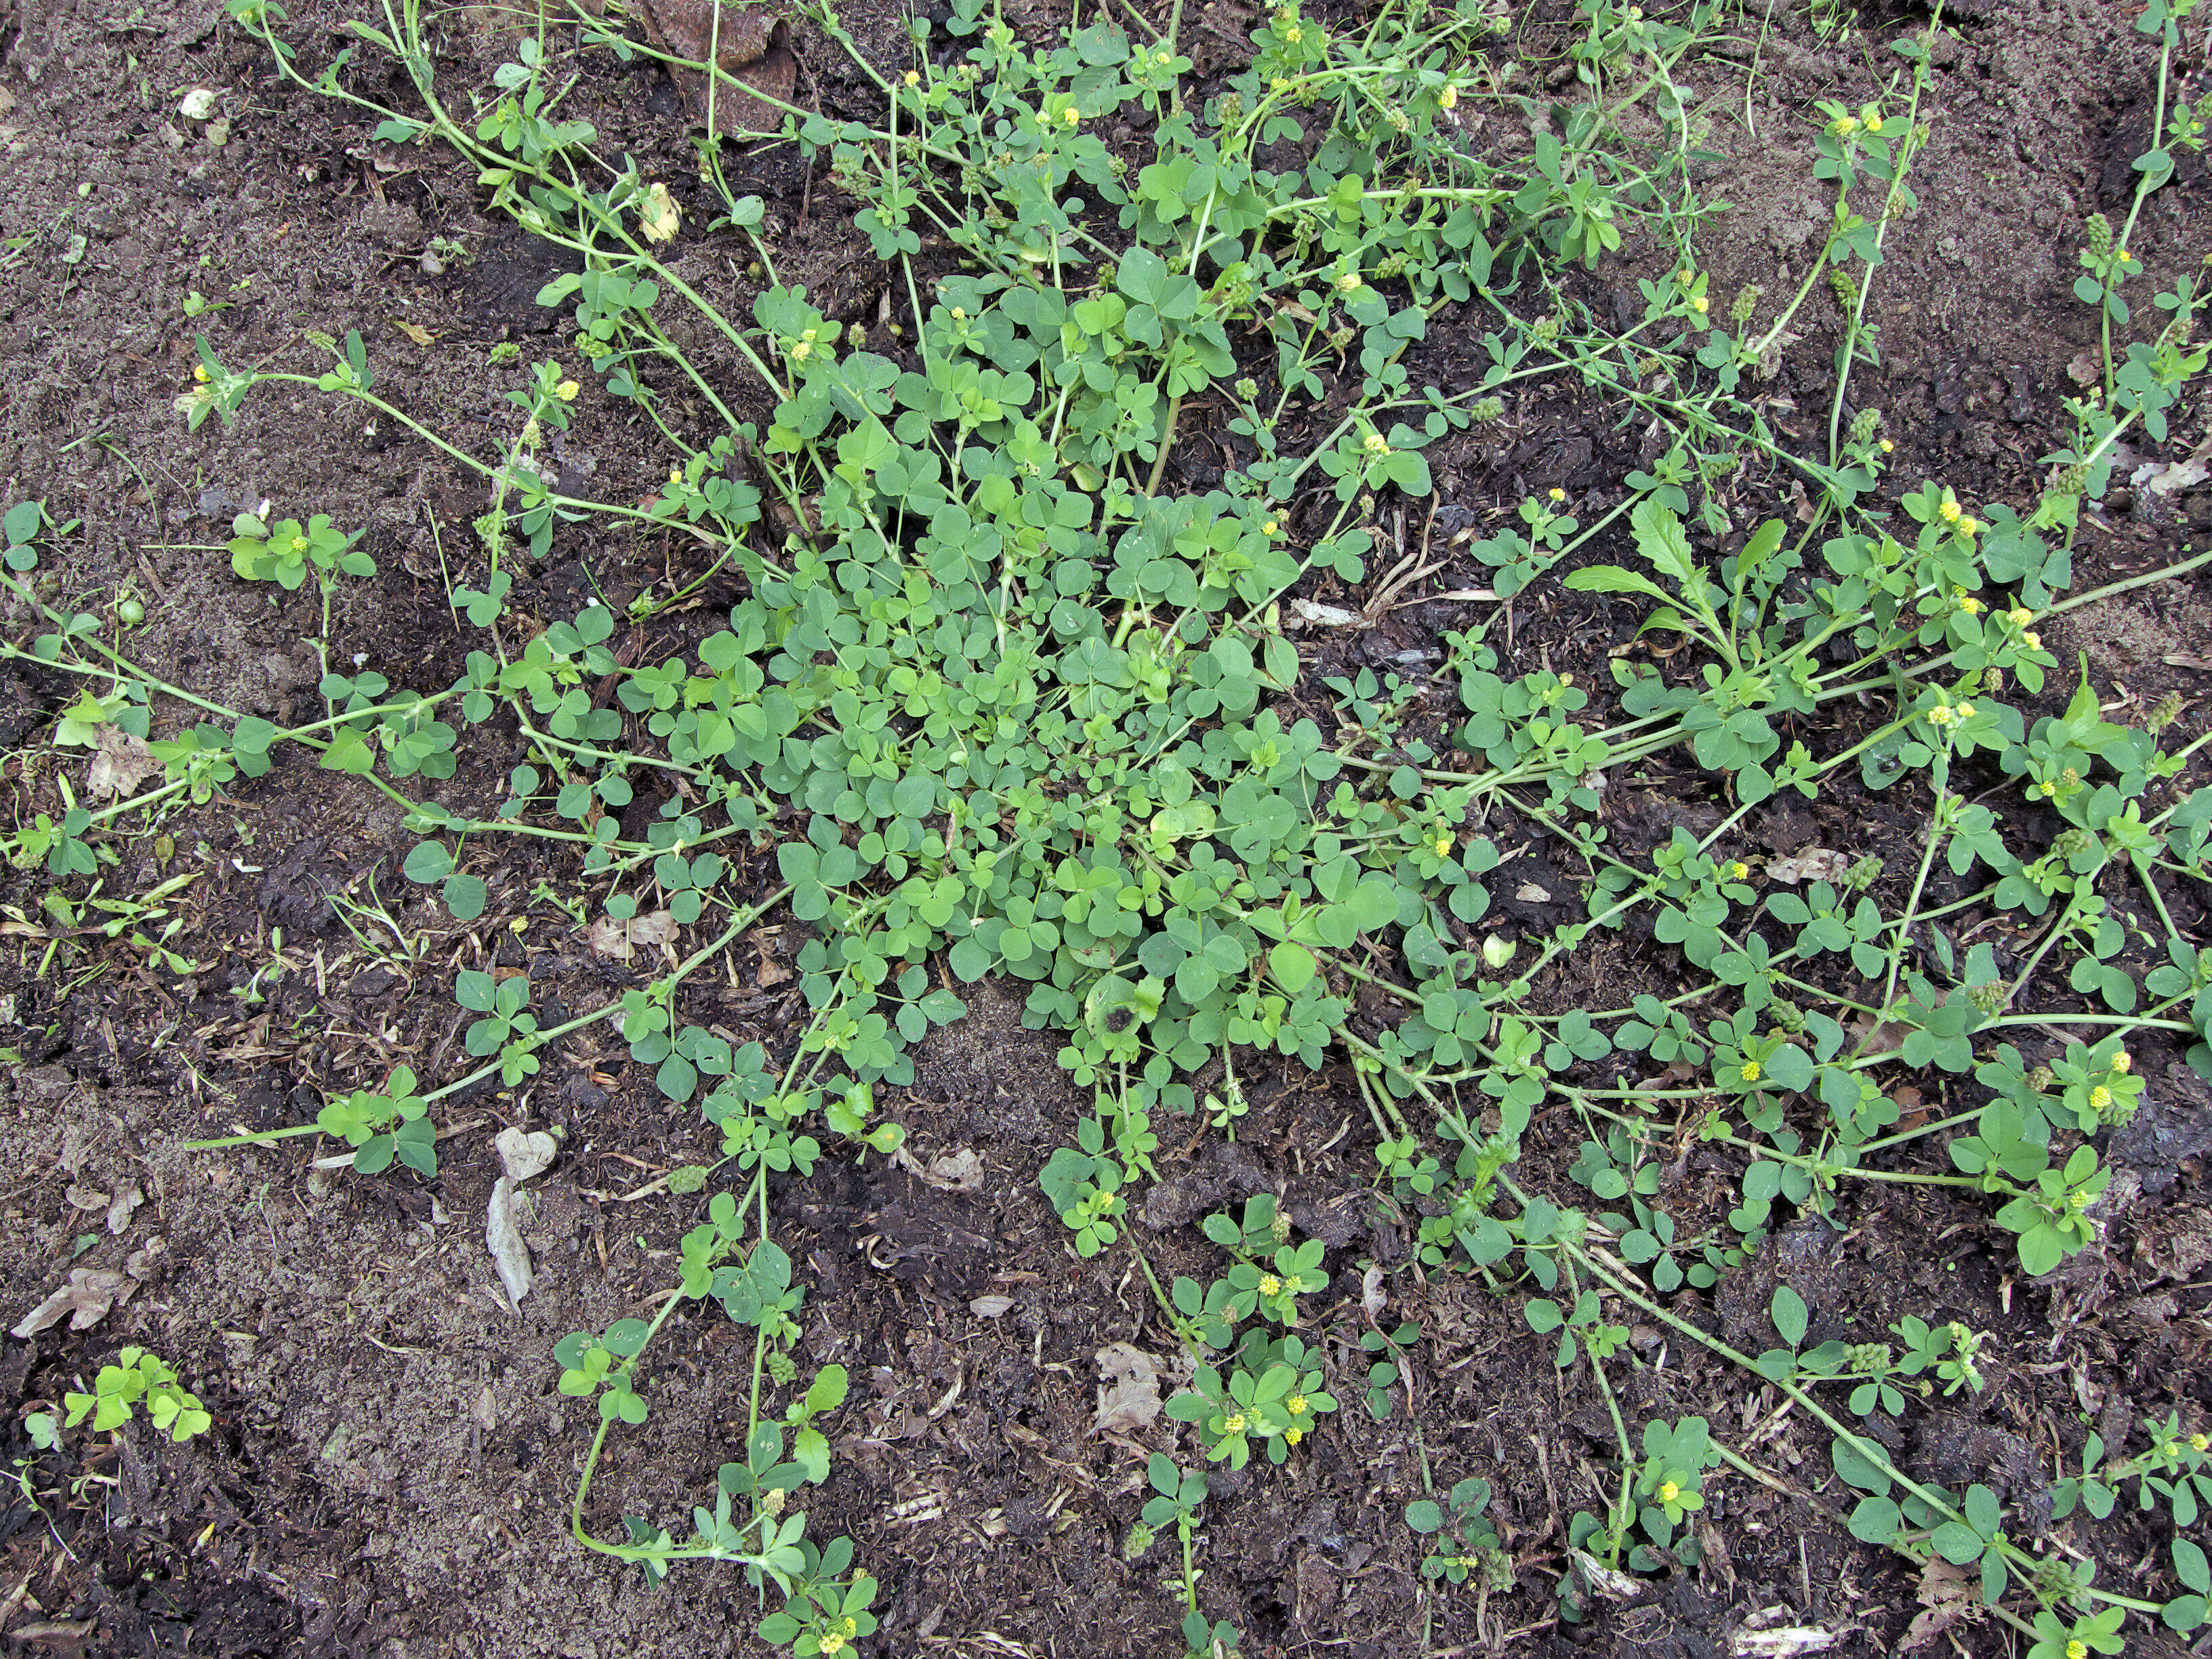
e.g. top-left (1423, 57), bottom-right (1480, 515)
top-left (90, 0), bottom-right (2212, 1659)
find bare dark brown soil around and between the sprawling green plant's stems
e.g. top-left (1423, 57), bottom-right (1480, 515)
top-left (0, 0), bottom-right (2212, 1659)
